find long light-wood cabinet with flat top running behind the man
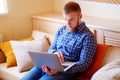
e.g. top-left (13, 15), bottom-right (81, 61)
top-left (31, 13), bottom-right (120, 47)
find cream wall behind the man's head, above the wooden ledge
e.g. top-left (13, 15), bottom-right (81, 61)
top-left (54, 0), bottom-right (120, 20)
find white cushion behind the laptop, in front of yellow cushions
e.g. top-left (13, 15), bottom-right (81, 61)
top-left (10, 36), bottom-right (49, 72)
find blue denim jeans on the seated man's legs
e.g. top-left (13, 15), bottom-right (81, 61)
top-left (20, 67), bottom-right (75, 80)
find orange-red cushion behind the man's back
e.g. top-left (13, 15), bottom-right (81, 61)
top-left (85, 44), bottom-right (109, 77)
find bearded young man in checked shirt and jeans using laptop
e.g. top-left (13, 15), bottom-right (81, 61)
top-left (21, 2), bottom-right (97, 80)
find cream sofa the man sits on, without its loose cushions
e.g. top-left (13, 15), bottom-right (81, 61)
top-left (0, 32), bottom-right (120, 80)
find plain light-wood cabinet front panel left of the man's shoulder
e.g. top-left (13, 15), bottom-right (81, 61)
top-left (33, 19), bottom-right (64, 34)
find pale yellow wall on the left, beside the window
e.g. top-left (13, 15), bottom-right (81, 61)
top-left (0, 0), bottom-right (53, 41)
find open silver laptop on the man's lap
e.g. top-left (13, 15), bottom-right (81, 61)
top-left (28, 52), bottom-right (75, 72)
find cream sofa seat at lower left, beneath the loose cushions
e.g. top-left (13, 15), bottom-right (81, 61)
top-left (0, 63), bottom-right (27, 80)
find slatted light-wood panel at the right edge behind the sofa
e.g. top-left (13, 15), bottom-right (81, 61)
top-left (104, 31), bottom-right (120, 47)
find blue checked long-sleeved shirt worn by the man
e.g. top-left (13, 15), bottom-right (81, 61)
top-left (48, 22), bottom-right (97, 73)
